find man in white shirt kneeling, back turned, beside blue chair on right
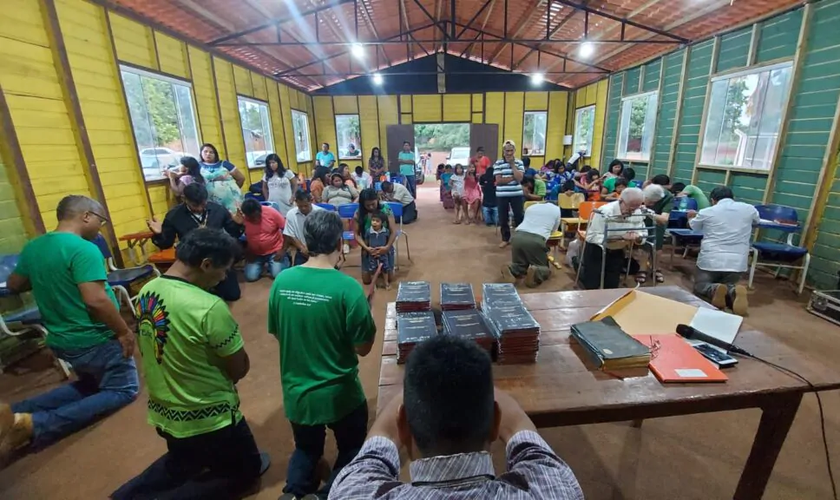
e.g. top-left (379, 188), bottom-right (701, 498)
top-left (688, 186), bottom-right (760, 316)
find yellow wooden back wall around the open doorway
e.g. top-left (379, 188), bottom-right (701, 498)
top-left (312, 91), bottom-right (568, 168)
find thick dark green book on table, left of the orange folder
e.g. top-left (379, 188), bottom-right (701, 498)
top-left (572, 316), bottom-right (650, 371)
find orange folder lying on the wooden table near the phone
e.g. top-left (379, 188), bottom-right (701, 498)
top-left (633, 334), bottom-right (728, 383)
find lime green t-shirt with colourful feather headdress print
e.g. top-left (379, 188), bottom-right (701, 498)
top-left (135, 276), bottom-right (245, 438)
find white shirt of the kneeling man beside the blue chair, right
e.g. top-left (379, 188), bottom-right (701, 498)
top-left (688, 198), bottom-right (760, 273)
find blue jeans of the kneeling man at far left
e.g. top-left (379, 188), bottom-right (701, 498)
top-left (12, 339), bottom-right (139, 448)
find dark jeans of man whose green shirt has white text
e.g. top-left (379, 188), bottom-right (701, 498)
top-left (283, 401), bottom-right (368, 499)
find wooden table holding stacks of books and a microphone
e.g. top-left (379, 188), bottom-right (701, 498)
top-left (377, 286), bottom-right (840, 499)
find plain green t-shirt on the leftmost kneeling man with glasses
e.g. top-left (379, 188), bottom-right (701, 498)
top-left (15, 232), bottom-right (120, 349)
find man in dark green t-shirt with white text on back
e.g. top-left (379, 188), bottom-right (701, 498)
top-left (268, 210), bottom-right (376, 500)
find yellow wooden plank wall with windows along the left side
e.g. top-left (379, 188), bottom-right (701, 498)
top-left (0, 0), bottom-right (316, 250)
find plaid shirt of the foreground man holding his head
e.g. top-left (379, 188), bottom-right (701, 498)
top-left (330, 431), bottom-right (583, 500)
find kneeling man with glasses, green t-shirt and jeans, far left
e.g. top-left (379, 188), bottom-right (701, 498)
top-left (0, 195), bottom-right (138, 463)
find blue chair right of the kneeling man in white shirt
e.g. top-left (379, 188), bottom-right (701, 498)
top-left (747, 205), bottom-right (811, 294)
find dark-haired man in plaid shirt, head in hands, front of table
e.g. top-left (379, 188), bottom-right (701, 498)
top-left (330, 335), bottom-right (583, 500)
